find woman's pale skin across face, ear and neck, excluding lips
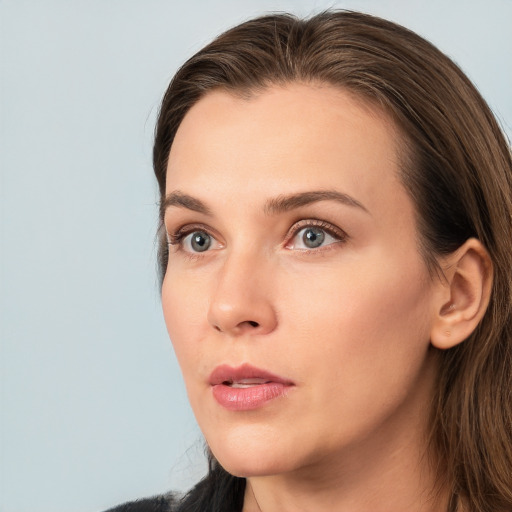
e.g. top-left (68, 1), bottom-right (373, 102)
top-left (162, 84), bottom-right (491, 512)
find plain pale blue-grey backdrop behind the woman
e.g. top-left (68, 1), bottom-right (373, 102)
top-left (0, 0), bottom-right (512, 512)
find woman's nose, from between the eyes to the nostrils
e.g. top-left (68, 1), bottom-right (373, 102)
top-left (208, 248), bottom-right (277, 336)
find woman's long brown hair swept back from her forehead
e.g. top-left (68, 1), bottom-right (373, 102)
top-left (153, 11), bottom-right (512, 512)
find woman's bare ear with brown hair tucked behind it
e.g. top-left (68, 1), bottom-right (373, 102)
top-left (430, 238), bottom-right (493, 349)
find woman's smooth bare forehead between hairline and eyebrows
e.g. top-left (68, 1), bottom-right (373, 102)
top-left (167, 84), bottom-right (408, 211)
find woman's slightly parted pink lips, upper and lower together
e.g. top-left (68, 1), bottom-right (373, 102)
top-left (209, 364), bottom-right (294, 411)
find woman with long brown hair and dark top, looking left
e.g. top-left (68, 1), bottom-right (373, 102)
top-left (108, 8), bottom-right (512, 512)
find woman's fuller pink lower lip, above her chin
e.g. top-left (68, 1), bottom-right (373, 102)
top-left (212, 382), bottom-right (290, 411)
